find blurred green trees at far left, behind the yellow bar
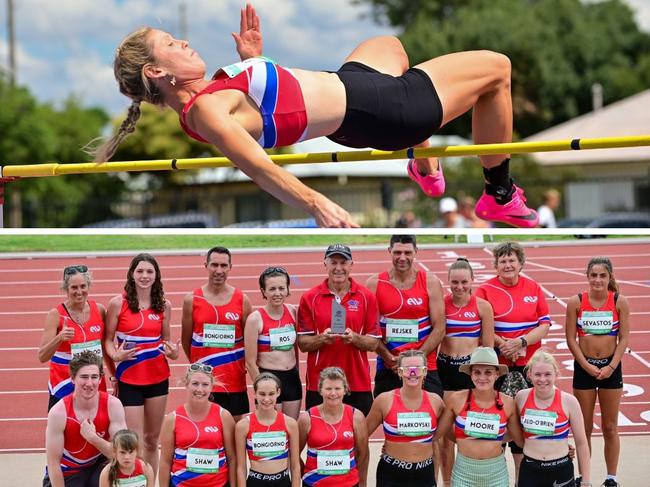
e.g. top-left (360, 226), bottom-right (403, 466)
top-left (0, 73), bottom-right (123, 227)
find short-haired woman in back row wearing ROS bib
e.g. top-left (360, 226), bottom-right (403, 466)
top-left (244, 267), bottom-right (302, 419)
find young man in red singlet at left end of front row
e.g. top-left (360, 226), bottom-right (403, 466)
top-left (43, 350), bottom-right (126, 487)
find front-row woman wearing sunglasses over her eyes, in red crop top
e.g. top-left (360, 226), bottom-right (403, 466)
top-left (366, 350), bottom-right (444, 487)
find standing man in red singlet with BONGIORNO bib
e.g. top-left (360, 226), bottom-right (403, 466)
top-left (181, 247), bottom-right (251, 421)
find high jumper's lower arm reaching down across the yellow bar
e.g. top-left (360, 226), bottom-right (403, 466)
top-left (188, 96), bottom-right (359, 228)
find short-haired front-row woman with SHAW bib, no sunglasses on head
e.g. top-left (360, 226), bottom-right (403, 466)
top-left (298, 367), bottom-right (369, 487)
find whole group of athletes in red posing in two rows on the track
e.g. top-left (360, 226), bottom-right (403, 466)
top-left (39, 239), bottom-right (629, 487)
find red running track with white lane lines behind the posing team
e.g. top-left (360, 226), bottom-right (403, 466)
top-left (0, 242), bottom-right (650, 453)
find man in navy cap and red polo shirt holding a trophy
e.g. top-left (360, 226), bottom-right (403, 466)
top-left (298, 244), bottom-right (381, 415)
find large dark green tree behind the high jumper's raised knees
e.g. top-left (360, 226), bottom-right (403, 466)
top-left (357, 0), bottom-right (650, 137)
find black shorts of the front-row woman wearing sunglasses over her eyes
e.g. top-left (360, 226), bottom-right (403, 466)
top-left (377, 454), bottom-right (436, 487)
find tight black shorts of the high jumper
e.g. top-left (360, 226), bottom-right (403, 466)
top-left (328, 61), bottom-right (442, 150)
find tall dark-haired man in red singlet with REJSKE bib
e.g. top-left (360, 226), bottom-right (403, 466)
top-left (366, 235), bottom-right (445, 397)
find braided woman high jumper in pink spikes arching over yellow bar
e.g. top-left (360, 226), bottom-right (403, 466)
top-left (95, 6), bottom-right (537, 227)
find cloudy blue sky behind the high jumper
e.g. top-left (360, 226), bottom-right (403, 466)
top-left (0, 0), bottom-right (650, 115)
